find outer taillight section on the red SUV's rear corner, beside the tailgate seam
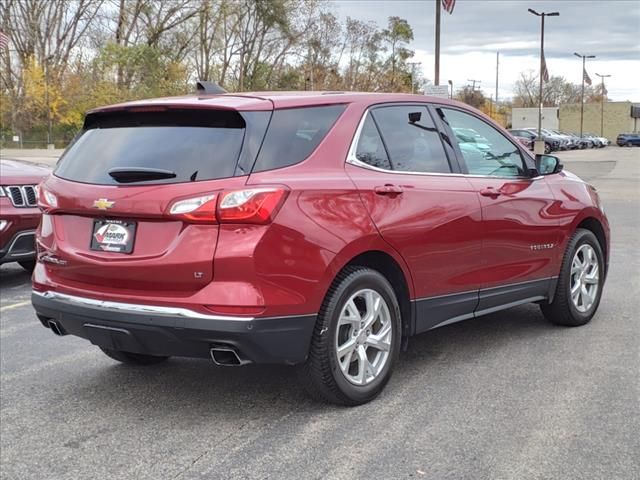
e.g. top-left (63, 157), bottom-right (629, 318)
top-left (218, 187), bottom-right (289, 224)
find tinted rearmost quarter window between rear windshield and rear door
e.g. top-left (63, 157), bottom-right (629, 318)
top-left (253, 105), bottom-right (346, 172)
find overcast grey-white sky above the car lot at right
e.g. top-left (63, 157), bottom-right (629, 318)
top-left (332, 0), bottom-right (640, 102)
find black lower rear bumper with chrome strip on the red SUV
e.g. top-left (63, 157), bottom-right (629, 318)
top-left (31, 291), bottom-right (316, 365)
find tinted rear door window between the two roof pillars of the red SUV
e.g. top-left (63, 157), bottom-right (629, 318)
top-left (373, 105), bottom-right (451, 173)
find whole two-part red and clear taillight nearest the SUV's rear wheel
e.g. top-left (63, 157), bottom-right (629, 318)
top-left (169, 187), bottom-right (289, 224)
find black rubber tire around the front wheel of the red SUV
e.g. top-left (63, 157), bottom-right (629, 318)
top-left (540, 228), bottom-right (605, 327)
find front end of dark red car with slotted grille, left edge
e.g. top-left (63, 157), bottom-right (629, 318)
top-left (0, 159), bottom-right (49, 271)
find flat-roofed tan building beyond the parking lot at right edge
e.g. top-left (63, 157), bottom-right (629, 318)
top-left (556, 102), bottom-right (640, 142)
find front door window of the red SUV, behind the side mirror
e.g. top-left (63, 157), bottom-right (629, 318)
top-left (441, 108), bottom-right (524, 177)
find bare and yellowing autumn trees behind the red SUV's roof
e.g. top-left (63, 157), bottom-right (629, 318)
top-left (0, 0), bottom-right (422, 143)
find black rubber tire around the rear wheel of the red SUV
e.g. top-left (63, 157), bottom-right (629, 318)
top-left (298, 267), bottom-right (402, 406)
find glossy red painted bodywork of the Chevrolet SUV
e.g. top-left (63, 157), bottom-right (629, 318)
top-left (33, 93), bottom-right (609, 317)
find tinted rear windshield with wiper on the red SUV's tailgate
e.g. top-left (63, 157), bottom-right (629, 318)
top-left (55, 110), bottom-right (248, 185)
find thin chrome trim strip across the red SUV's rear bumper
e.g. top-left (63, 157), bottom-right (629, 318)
top-left (33, 290), bottom-right (255, 322)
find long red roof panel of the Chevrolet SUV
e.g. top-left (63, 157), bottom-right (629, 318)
top-left (89, 91), bottom-right (465, 113)
